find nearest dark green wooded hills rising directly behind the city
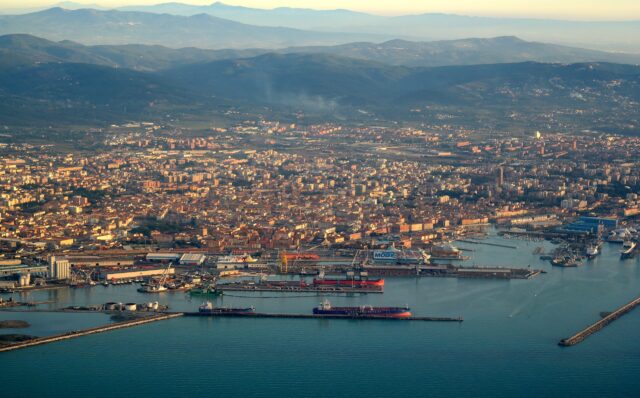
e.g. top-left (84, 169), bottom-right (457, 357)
top-left (0, 36), bottom-right (640, 130)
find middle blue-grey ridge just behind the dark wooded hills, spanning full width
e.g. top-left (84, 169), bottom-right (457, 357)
top-left (0, 34), bottom-right (640, 71)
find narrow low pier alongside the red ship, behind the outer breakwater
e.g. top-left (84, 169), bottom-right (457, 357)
top-left (217, 281), bottom-right (384, 293)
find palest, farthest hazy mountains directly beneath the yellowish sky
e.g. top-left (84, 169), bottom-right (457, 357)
top-left (2, 2), bottom-right (640, 53)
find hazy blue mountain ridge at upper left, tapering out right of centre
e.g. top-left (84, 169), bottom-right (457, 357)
top-left (0, 8), bottom-right (381, 49)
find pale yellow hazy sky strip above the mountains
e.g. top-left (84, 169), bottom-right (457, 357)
top-left (0, 0), bottom-right (640, 20)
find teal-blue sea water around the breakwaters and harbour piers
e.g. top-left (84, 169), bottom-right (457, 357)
top-left (0, 238), bottom-right (640, 397)
